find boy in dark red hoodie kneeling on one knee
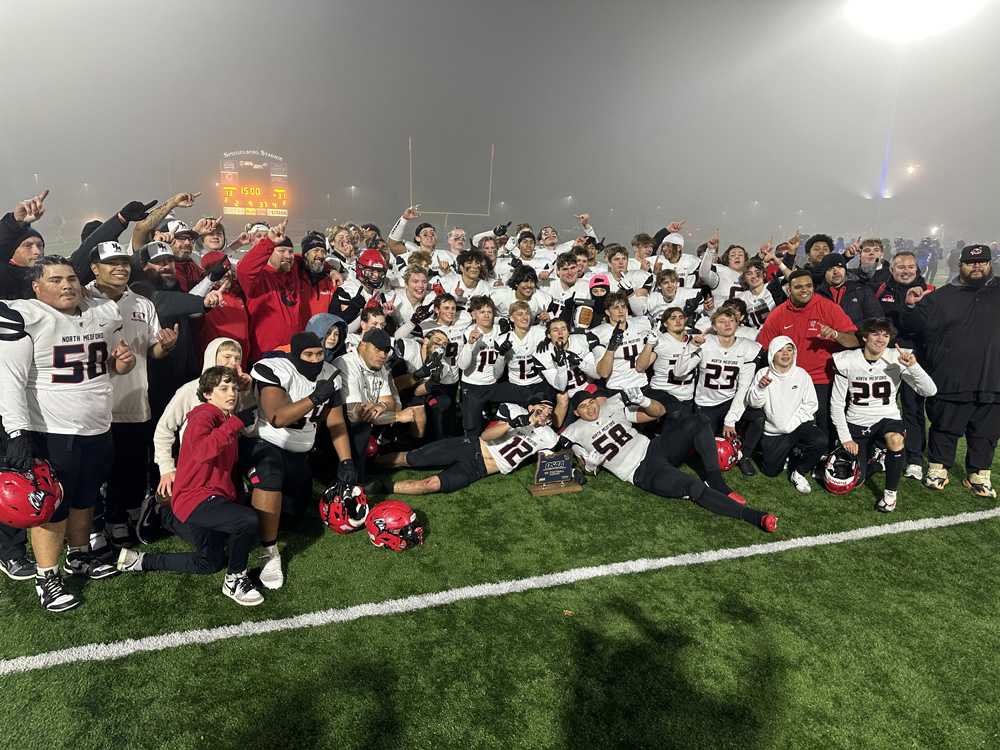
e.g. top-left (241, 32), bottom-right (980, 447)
top-left (118, 367), bottom-right (264, 606)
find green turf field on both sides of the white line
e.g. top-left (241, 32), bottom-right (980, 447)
top-left (0, 450), bottom-right (1000, 748)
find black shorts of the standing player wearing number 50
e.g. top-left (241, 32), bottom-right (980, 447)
top-left (32, 430), bottom-right (115, 523)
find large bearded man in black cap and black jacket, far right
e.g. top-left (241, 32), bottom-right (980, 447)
top-left (900, 245), bottom-right (1000, 498)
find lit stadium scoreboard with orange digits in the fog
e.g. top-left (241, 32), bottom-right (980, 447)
top-left (219, 149), bottom-right (289, 218)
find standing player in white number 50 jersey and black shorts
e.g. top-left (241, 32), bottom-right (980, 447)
top-left (0, 256), bottom-right (135, 612)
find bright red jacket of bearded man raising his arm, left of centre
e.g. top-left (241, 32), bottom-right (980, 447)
top-left (236, 237), bottom-right (311, 362)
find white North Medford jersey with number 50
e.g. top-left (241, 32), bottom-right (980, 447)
top-left (0, 299), bottom-right (125, 435)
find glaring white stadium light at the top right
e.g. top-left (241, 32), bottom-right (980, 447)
top-left (844, 0), bottom-right (987, 44)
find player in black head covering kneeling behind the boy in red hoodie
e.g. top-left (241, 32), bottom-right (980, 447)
top-left (248, 331), bottom-right (357, 589)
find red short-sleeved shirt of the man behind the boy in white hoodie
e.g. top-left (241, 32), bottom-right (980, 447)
top-left (757, 294), bottom-right (858, 385)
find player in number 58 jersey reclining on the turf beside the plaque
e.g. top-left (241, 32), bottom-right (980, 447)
top-left (562, 389), bottom-right (778, 532)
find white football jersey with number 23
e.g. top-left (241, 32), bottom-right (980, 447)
top-left (675, 334), bottom-right (760, 414)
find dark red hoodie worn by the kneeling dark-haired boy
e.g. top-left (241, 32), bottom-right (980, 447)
top-left (170, 404), bottom-right (243, 521)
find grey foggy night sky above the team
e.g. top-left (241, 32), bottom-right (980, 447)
top-left (0, 0), bottom-right (1000, 245)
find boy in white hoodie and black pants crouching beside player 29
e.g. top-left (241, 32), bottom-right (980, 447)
top-left (747, 336), bottom-right (826, 495)
